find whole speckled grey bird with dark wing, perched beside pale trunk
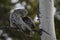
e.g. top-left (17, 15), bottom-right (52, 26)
top-left (10, 9), bottom-right (34, 32)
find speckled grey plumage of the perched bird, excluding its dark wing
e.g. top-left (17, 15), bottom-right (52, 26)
top-left (10, 9), bottom-right (32, 32)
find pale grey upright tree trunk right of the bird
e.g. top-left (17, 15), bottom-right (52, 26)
top-left (39, 0), bottom-right (56, 40)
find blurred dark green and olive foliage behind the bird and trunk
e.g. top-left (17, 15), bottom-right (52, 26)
top-left (0, 0), bottom-right (60, 40)
